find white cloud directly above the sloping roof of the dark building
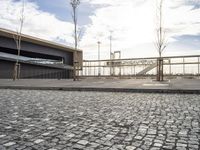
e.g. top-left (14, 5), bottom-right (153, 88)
top-left (0, 0), bottom-right (73, 44)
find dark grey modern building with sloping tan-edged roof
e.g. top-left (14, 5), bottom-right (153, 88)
top-left (0, 28), bottom-right (83, 79)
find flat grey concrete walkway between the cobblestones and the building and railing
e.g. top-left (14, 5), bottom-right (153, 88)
top-left (0, 78), bottom-right (200, 93)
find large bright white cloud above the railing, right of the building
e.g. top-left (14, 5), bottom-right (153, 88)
top-left (81, 0), bottom-right (200, 59)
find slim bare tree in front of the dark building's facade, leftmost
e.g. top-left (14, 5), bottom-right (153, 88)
top-left (13, 0), bottom-right (25, 80)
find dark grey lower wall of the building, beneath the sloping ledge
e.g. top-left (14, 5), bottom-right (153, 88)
top-left (0, 60), bottom-right (72, 79)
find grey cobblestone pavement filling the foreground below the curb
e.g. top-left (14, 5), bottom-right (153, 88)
top-left (0, 90), bottom-right (200, 150)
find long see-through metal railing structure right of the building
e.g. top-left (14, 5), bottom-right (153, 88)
top-left (79, 55), bottom-right (200, 77)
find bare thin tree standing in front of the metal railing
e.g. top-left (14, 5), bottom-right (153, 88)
top-left (156, 0), bottom-right (167, 81)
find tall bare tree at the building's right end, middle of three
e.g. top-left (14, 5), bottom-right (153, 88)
top-left (70, 0), bottom-right (80, 81)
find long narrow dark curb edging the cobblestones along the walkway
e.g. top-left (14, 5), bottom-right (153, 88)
top-left (0, 86), bottom-right (200, 94)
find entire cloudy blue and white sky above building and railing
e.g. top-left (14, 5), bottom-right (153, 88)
top-left (0, 0), bottom-right (200, 59)
